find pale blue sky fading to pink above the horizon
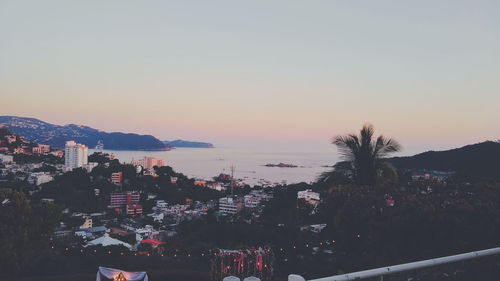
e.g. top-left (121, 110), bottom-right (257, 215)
top-left (0, 0), bottom-right (500, 154)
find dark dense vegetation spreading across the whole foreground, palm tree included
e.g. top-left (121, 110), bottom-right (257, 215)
top-left (0, 127), bottom-right (500, 280)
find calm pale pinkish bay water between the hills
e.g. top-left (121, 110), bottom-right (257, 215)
top-left (90, 147), bottom-right (337, 185)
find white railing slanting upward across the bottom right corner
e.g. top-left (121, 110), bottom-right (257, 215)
top-left (288, 247), bottom-right (500, 281)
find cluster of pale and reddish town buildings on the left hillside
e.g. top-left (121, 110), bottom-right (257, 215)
top-left (0, 129), bottom-right (286, 254)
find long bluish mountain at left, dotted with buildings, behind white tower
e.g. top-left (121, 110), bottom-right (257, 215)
top-left (0, 116), bottom-right (170, 150)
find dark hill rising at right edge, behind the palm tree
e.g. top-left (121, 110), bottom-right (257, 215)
top-left (388, 141), bottom-right (500, 179)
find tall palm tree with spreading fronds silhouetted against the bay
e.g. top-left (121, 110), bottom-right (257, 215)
top-left (332, 124), bottom-right (401, 185)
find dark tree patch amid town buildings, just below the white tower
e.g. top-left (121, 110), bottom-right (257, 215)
top-left (29, 160), bottom-right (222, 212)
